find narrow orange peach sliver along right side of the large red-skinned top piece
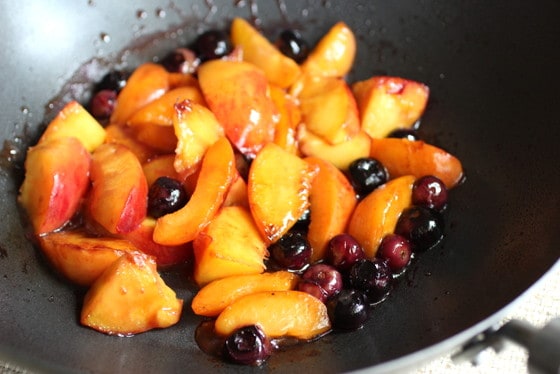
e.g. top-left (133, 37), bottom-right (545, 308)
top-left (270, 85), bottom-right (301, 154)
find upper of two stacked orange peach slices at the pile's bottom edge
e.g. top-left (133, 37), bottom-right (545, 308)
top-left (191, 270), bottom-right (299, 317)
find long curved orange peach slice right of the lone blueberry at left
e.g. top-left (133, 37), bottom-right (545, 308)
top-left (154, 137), bottom-right (235, 245)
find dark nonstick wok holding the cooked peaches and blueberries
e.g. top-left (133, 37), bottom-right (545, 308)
top-left (0, 0), bottom-right (560, 373)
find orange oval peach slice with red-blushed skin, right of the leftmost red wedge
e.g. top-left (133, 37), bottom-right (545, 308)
top-left (88, 144), bottom-right (148, 234)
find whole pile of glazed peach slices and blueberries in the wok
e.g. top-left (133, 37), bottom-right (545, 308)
top-left (19, 19), bottom-right (463, 364)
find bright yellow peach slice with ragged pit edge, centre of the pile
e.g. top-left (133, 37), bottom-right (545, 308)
top-left (247, 143), bottom-right (317, 244)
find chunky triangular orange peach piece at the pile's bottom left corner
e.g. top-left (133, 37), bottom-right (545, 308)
top-left (80, 253), bottom-right (183, 336)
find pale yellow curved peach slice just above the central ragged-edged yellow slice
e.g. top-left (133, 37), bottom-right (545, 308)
top-left (297, 126), bottom-right (371, 170)
